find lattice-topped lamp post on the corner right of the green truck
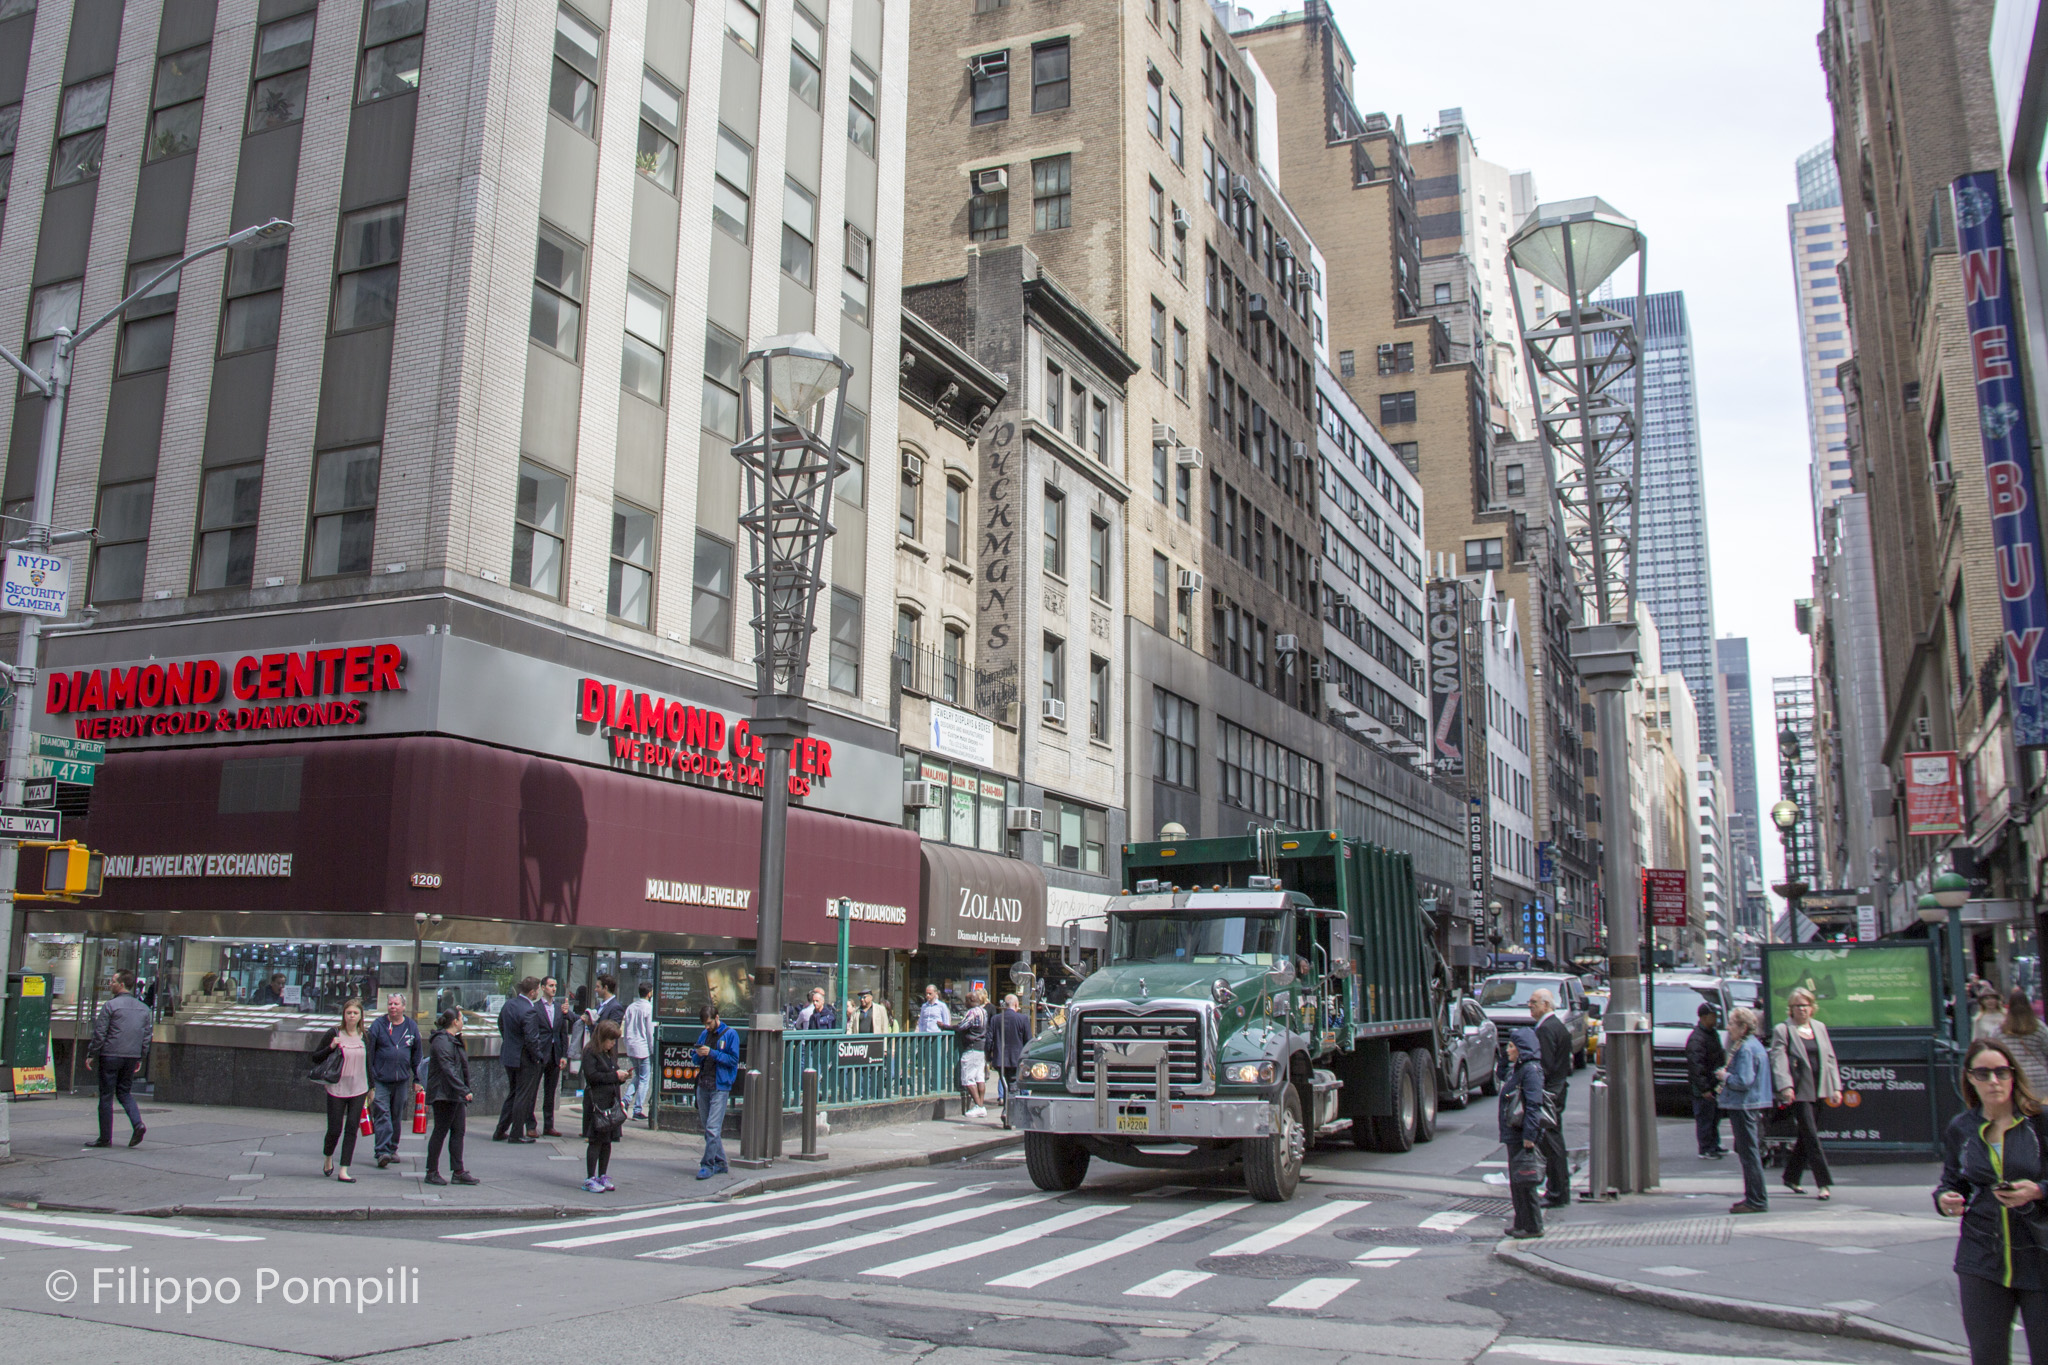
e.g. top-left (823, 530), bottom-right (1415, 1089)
top-left (1507, 199), bottom-right (1657, 1195)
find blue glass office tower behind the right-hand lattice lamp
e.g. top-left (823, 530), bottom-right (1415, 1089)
top-left (1604, 291), bottom-right (1720, 759)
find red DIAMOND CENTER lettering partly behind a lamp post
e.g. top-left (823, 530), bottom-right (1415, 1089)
top-left (575, 677), bottom-right (831, 796)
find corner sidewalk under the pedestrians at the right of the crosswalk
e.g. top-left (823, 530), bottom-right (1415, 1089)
top-left (1495, 1119), bottom-right (1966, 1355)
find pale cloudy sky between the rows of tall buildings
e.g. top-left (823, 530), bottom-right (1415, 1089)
top-left (1310, 0), bottom-right (1829, 884)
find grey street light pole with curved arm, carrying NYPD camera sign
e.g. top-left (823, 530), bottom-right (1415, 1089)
top-left (0, 219), bottom-right (291, 1160)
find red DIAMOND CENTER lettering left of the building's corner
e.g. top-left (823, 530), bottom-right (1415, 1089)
top-left (43, 643), bottom-right (406, 741)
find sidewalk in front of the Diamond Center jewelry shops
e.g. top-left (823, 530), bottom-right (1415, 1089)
top-left (0, 1095), bottom-right (1022, 1218)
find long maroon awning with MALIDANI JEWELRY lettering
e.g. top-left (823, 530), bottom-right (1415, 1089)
top-left (70, 737), bottom-right (920, 950)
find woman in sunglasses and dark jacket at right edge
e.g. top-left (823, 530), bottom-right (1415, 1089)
top-left (1933, 1038), bottom-right (2048, 1365)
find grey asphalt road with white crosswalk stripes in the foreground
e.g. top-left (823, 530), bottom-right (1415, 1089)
top-left (0, 1101), bottom-right (1941, 1365)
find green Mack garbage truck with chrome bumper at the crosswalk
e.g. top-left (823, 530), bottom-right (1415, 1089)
top-left (1010, 829), bottom-right (1448, 1201)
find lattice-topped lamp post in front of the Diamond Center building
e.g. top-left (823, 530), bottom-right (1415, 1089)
top-left (733, 332), bottom-right (854, 1164)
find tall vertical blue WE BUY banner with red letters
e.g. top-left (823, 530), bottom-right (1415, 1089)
top-left (1949, 170), bottom-right (2048, 749)
